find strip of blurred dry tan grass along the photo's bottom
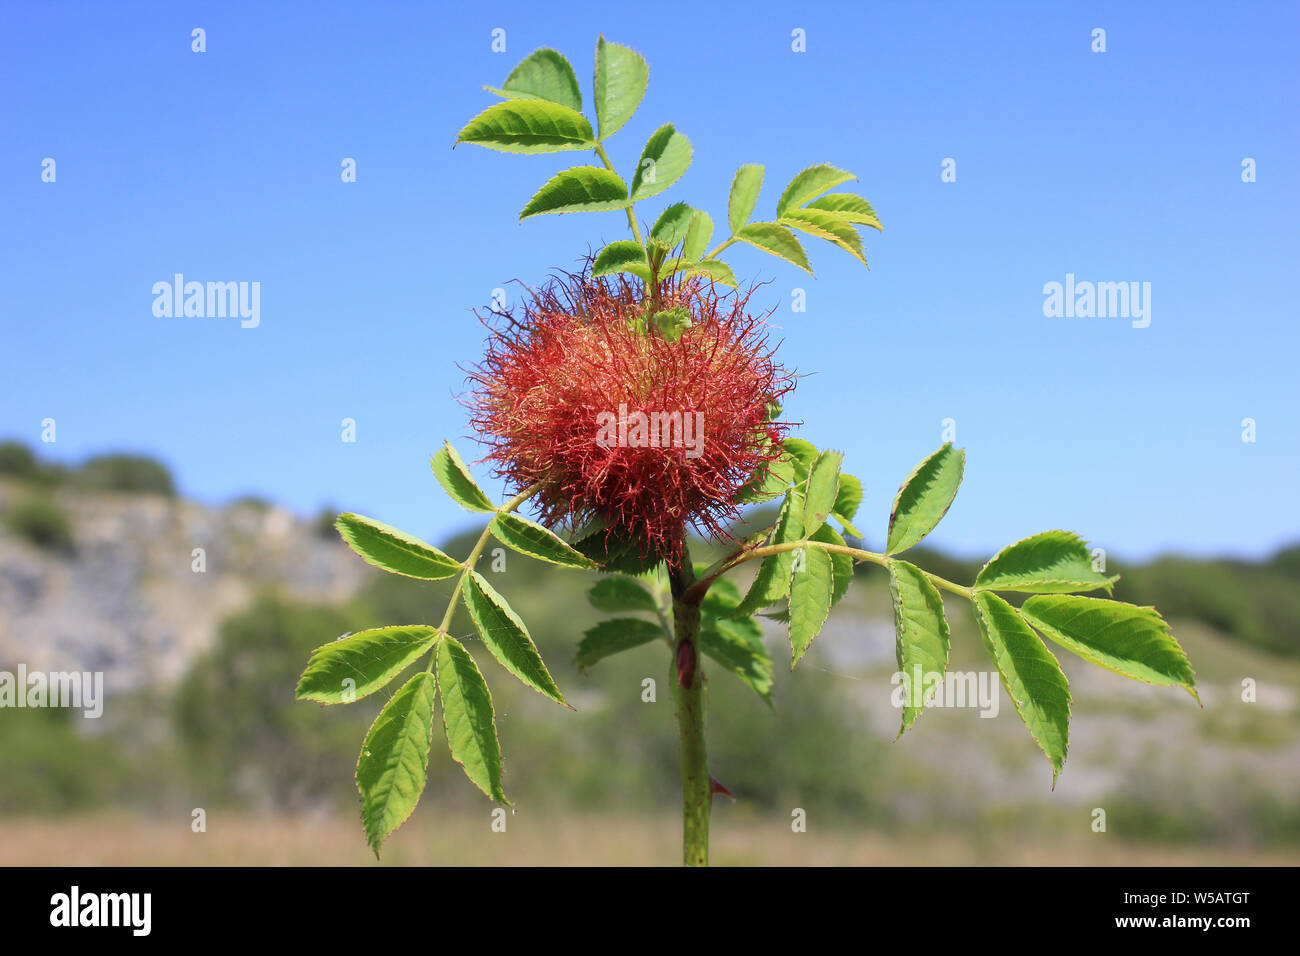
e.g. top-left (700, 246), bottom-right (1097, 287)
top-left (0, 813), bottom-right (1300, 866)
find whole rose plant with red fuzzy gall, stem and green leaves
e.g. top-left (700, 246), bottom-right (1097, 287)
top-left (298, 36), bottom-right (1196, 865)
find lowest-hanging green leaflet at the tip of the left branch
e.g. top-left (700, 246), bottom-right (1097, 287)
top-left (356, 672), bottom-right (438, 856)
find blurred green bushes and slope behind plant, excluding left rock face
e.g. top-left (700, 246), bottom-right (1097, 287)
top-left (0, 444), bottom-right (1300, 862)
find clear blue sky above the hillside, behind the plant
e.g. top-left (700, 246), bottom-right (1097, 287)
top-left (0, 0), bottom-right (1300, 557)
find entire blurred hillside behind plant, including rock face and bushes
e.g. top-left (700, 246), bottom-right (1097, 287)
top-left (0, 444), bottom-right (1300, 862)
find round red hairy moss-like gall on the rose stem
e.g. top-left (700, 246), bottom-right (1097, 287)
top-left (465, 269), bottom-right (793, 561)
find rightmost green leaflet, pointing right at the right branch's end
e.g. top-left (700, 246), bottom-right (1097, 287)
top-left (1021, 594), bottom-right (1200, 700)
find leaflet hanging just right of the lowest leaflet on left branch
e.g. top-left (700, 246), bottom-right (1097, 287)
top-left (436, 635), bottom-right (510, 805)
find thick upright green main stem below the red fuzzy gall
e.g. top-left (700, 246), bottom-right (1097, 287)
top-left (668, 546), bottom-right (712, 866)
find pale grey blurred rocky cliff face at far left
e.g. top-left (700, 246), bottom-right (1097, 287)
top-left (0, 484), bottom-right (369, 693)
